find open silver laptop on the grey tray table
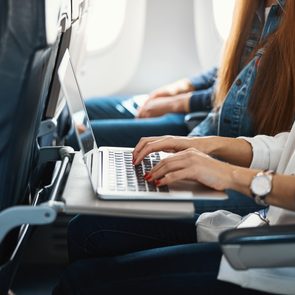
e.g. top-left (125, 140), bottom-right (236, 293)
top-left (58, 50), bottom-right (227, 201)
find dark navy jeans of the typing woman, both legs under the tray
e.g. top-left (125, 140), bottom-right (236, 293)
top-left (53, 216), bottom-right (265, 295)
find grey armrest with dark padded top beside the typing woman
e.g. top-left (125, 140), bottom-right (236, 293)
top-left (219, 225), bottom-right (295, 270)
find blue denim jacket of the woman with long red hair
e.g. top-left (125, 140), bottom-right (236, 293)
top-left (189, 0), bottom-right (285, 137)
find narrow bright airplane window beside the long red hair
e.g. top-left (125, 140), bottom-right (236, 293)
top-left (213, 0), bottom-right (235, 40)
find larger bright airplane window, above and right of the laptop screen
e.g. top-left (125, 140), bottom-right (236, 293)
top-left (87, 0), bottom-right (126, 51)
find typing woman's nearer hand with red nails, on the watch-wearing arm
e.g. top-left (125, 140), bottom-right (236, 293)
top-left (145, 148), bottom-right (234, 190)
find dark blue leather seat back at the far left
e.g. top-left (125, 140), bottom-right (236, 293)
top-left (0, 0), bottom-right (56, 210)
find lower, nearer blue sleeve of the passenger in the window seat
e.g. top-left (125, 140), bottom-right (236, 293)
top-left (189, 86), bottom-right (214, 112)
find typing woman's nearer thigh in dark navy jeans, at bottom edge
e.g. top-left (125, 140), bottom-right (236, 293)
top-left (53, 243), bottom-right (266, 295)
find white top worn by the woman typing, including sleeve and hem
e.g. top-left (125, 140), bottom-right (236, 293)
top-left (218, 123), bottom-right (295, 294)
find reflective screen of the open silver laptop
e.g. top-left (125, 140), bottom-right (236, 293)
top-left (58, 50), bottom-right (97, 155)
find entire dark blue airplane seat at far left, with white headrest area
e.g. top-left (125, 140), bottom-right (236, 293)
top-left (0, 0), bottom-right (70, 294)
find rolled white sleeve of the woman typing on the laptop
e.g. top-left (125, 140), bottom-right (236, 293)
top-left (239, 132), bottom-right (289, 170)
